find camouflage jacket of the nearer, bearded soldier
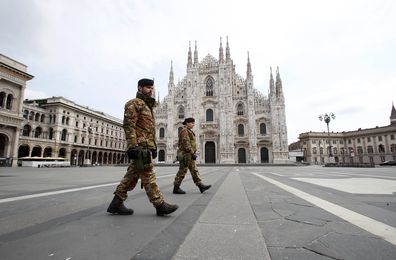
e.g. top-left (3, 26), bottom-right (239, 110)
top-left (124, 92), bottom-right (157, 149)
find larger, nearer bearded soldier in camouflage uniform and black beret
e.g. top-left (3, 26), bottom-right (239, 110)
top-left (107, 79), bottom-right (178, 216)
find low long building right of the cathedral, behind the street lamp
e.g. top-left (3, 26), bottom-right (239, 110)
top-left (299, 104), bottom-right (396, 164)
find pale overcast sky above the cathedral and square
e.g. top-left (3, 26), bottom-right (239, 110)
top-left (0, 0), bottom-right (396, 144)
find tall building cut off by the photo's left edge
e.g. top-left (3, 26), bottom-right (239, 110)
top-left (0, 54), bottom-right (33, 166)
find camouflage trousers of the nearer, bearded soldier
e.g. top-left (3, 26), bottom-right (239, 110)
top-left (114, 163), bottom-right (164, 207)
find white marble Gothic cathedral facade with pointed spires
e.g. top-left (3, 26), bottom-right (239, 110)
top-left (155, 39), bottom-right (289, 164)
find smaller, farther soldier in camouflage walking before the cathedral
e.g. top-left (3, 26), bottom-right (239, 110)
top-left (173, 117), bottom-right (212, 194)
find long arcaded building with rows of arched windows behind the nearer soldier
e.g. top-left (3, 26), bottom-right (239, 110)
top-left (17, 97), bottom-right (127, 166)
